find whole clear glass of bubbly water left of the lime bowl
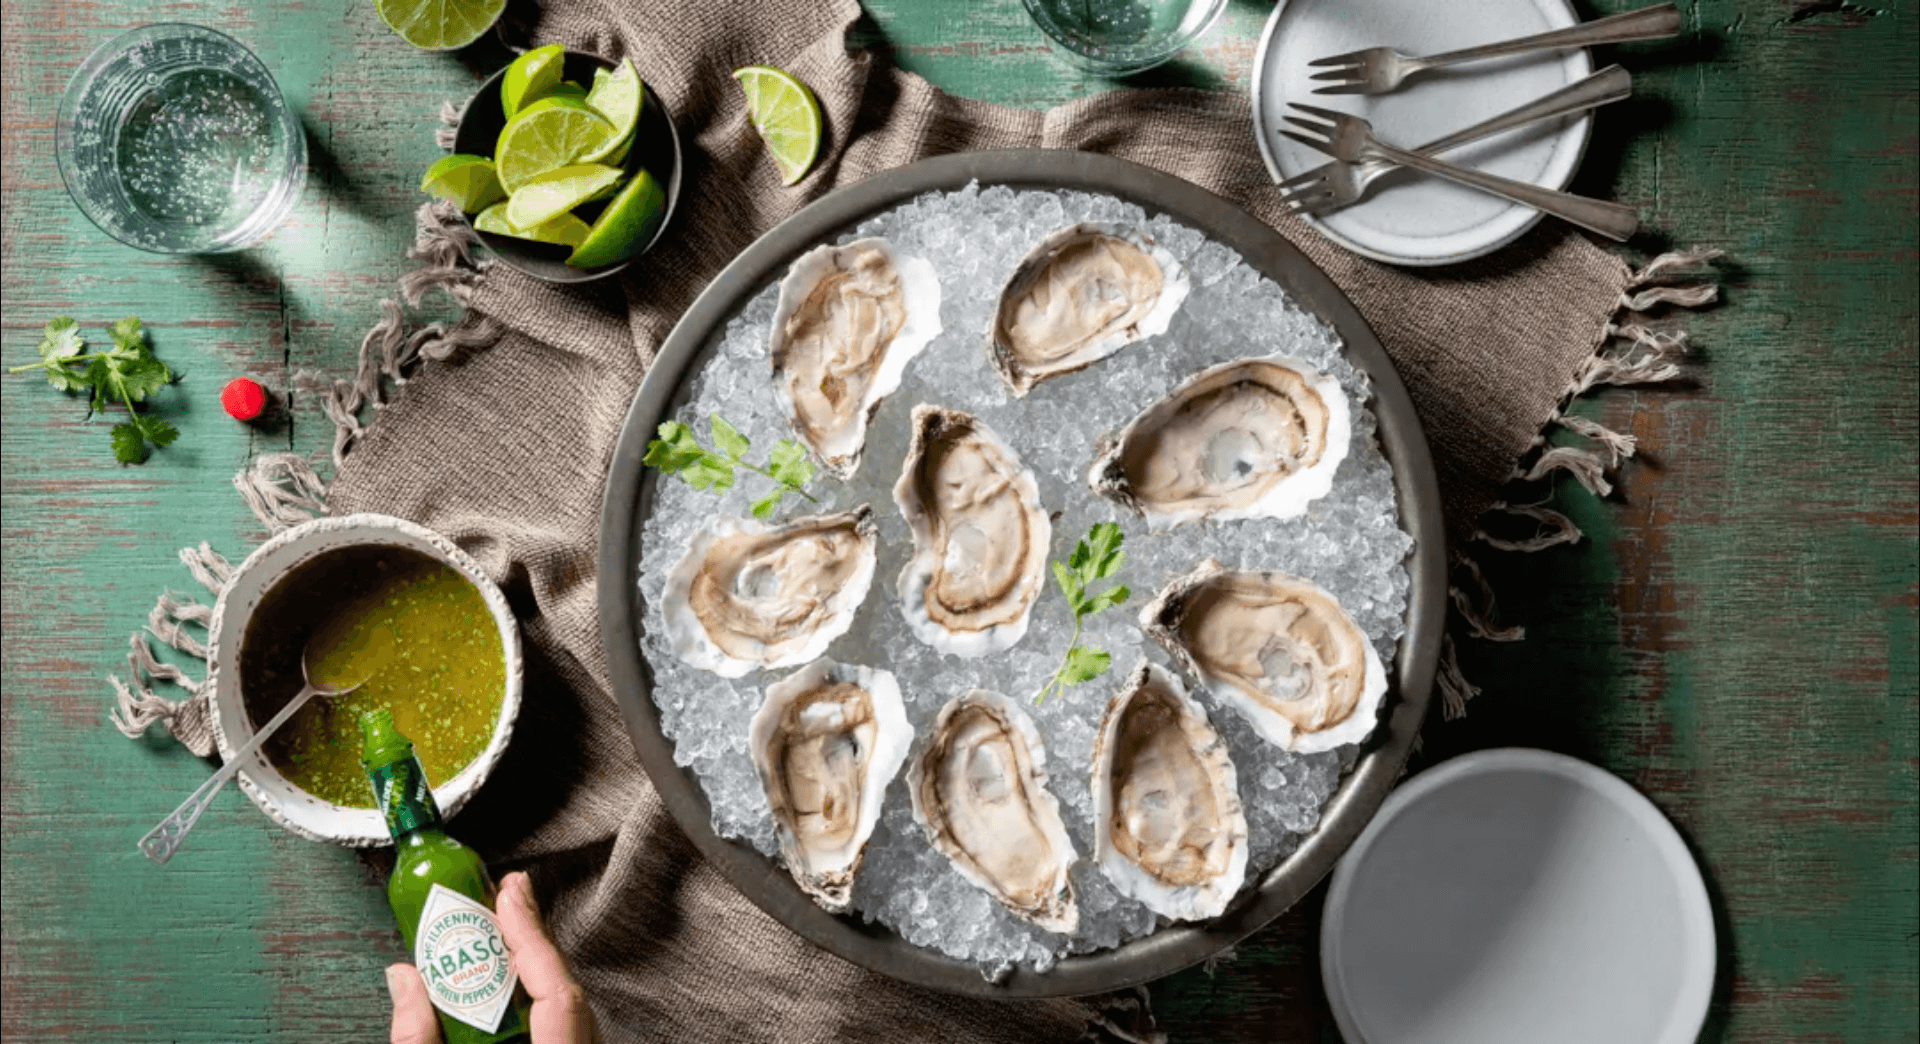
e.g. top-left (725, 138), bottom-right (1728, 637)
top-left (54, 23), bottom-right (307, 253)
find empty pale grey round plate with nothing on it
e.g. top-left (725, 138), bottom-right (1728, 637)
top-left (1321, 747), bottom-right (1715, 1044)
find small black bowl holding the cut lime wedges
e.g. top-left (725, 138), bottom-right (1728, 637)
top-left (453, 50), bottom-right (682, 282)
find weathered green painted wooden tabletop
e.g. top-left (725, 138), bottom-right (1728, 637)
top-left (0, 0), bottom-right (1920, 1042)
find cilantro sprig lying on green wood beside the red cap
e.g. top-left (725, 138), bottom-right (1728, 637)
top-left (8, 315), bottom-right (180, 464)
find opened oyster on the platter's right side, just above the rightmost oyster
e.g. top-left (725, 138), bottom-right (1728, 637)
top-left (1087, 355), bottom-right (1354, 530)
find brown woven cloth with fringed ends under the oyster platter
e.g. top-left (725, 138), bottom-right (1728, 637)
top-left (105, 0), bottom-right (1720, 1044)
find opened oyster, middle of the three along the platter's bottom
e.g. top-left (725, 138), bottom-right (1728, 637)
top-left (906, 689), bottom-right (1079, 935)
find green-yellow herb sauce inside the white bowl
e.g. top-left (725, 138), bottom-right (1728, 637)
top-left (240, 547), bottom-right (507, 808)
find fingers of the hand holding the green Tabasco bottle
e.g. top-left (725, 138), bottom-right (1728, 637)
top-left (386, 873), bottom-right (599, 1044)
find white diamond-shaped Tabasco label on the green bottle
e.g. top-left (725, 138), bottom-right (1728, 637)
top-left (413, 885), bottom-right (520, 1032)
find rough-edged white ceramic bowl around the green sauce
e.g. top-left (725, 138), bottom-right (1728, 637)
top-left (207, 514), bottom-right (522, 848)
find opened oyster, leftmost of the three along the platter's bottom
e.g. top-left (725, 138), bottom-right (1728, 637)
top-left (747, 656), bottom-right (914, 914)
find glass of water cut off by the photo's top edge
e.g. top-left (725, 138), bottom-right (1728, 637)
top-left (1023, 0), bottom-right (1227, 77)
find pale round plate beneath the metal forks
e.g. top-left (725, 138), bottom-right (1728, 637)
top-left (1254, 0), bottom-right (1594, 265)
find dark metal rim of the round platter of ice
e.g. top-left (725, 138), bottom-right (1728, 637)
top-left (599, 150), bottom-right (1446, 998)
